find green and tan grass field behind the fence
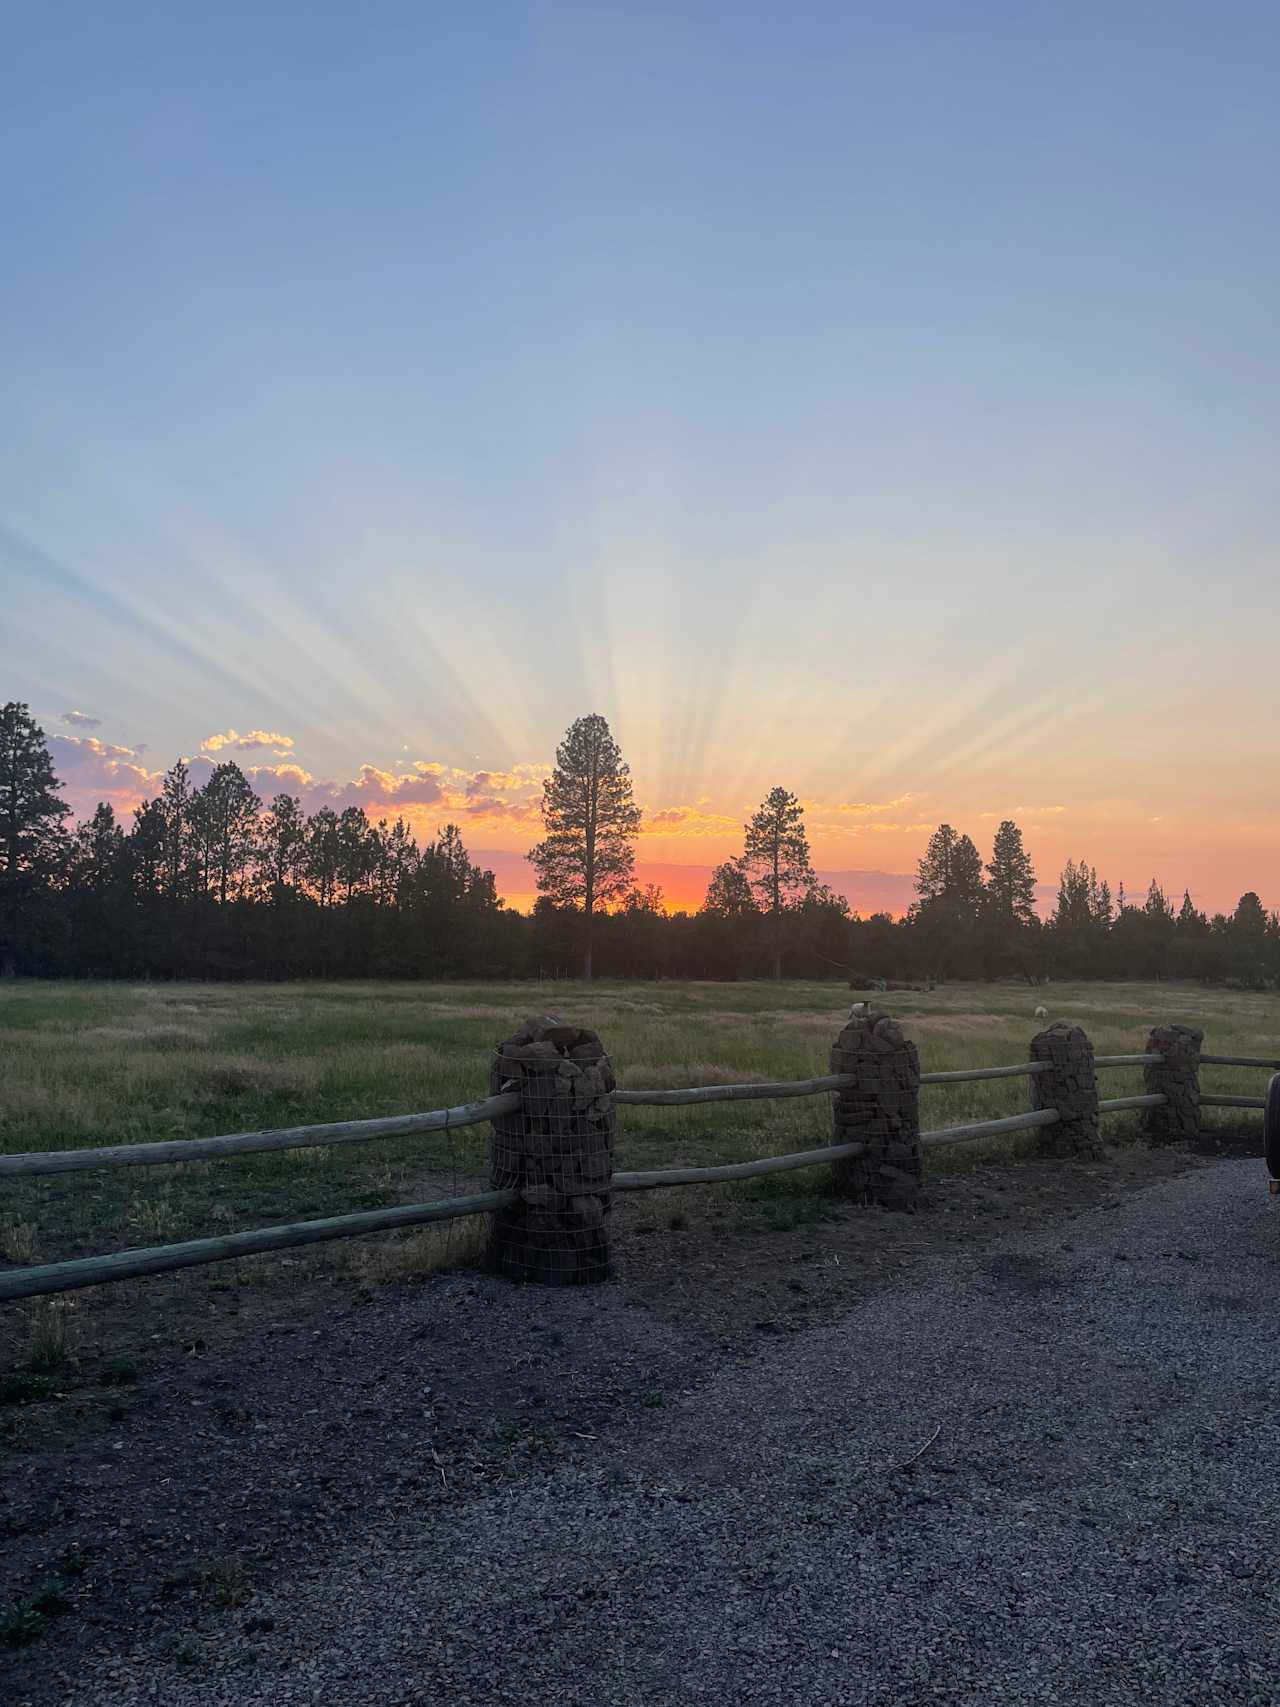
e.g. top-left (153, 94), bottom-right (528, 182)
top-left (0, 983), bottom-right (1280, 1261)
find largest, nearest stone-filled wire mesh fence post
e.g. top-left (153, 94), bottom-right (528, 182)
top-left (490, 1014), bottom-right (614, 1285)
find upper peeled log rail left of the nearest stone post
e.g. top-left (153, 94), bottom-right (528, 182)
top-left (0, 1092), bottom-right (521, 1178)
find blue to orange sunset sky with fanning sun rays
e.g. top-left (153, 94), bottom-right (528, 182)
top-left (0, 0), bottom-right (1280, 912)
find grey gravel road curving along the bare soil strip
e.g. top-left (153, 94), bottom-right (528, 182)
top-left (10, 1161), bottom-right (1280, 1707)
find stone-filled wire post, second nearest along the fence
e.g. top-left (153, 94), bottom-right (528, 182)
top-left (831, 1004), bottom-right (925, 1209)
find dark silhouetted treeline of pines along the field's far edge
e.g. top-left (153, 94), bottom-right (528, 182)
top-left (0, 703), bottom-right (1280, 988)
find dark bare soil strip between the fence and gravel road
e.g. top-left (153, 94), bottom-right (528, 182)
top-left (0, 1149), bottom-right (1208, 1707)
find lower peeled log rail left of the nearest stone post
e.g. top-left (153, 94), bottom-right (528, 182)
top-left (0, 1191), bottom-right (517, 1299)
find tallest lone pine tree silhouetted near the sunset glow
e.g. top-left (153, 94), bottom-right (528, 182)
top-left (527, 714), bottom-right (640, 978)
